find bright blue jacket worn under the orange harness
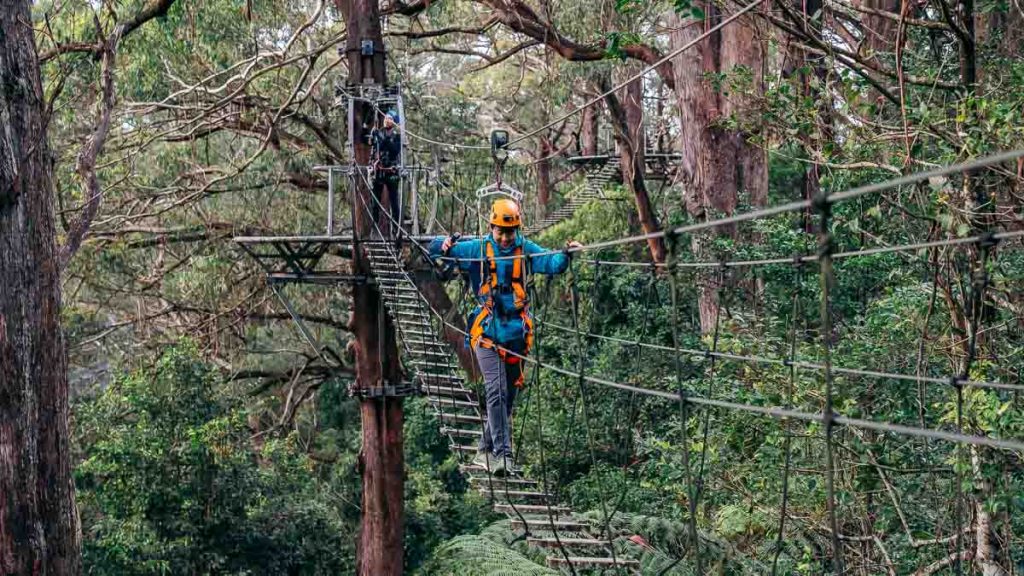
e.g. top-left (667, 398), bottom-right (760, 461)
top-left (428, 234), bottom-right (569, 352)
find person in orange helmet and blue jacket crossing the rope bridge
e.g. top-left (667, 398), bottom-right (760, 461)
top-left (429, 199), bottom-right (580, 475)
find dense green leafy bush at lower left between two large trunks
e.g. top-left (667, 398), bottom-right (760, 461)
top-left (75, 344), bottom-right (352, 575)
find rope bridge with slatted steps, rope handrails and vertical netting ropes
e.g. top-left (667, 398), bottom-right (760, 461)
top-left (344, 146), bottom-right (1024, 574)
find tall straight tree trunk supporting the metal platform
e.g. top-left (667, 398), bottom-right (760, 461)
top-left (337, 0), bottom-right (404, 576)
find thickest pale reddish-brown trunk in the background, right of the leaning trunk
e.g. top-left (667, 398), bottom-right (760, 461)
top-left (668, 3), bottom-right (768, 333)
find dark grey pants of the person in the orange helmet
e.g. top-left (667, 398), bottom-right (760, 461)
top-left (473, 346), bottom-right (522, 456)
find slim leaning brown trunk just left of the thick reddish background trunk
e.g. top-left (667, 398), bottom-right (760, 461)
top-left (601, 72), bottom-right (666, 263)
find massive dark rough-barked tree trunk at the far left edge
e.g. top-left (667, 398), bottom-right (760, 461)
top-left (0, 0), bottom-right (81, 575)
